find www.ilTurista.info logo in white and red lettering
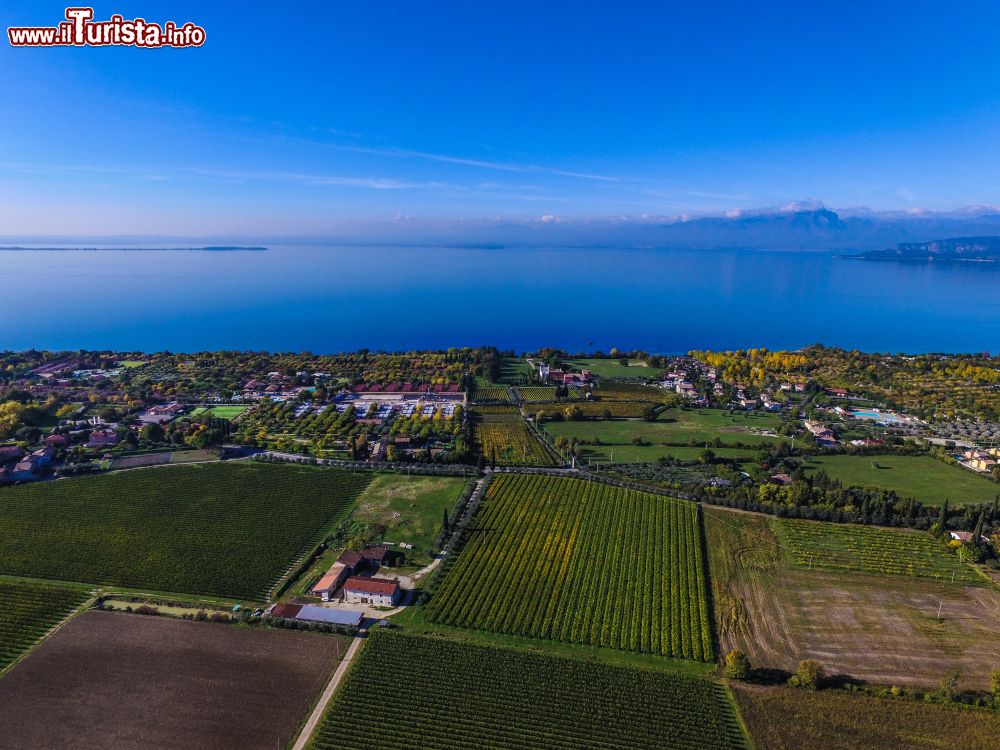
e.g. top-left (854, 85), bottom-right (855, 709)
top-left (7, 8), bottom-right (205, 47)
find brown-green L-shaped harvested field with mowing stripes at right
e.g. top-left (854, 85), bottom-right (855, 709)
top-left (703, 508), bottom-right (1000, 690)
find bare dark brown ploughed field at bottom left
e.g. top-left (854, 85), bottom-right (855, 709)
top-left (0, 611), bottom-right (346, 750)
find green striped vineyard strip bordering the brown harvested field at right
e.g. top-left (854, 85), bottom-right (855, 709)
top-left (773, 519), bottom-right (985, 583)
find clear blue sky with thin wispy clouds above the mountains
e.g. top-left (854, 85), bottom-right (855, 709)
top-left (0, 0), bottom-right (1000, 234)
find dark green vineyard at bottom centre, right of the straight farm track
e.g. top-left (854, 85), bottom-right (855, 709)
top-left (312, 631), bottom-right (746, 750)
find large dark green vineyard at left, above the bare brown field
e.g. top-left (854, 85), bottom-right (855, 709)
top-left (0, 463), bottom-right (371, 599)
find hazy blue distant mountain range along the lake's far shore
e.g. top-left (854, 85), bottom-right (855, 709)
top-left (9, 204), bottom-right (1000, 257)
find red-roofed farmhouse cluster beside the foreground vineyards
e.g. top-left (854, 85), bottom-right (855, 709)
top-left (312, 544), bottom-right (401, 607)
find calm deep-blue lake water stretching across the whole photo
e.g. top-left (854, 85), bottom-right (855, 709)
top-left (0, 245), bottom-right (1000, 353)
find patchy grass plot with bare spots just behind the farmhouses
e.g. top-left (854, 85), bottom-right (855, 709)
top-left (349, 474), bottom-right (468, 567)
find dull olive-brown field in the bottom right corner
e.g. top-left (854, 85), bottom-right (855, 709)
top-left (733, 685), bottom-right (1000, 750)
